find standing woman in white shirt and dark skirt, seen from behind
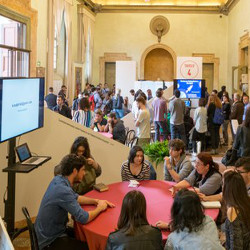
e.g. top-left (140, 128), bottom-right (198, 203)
top-left (192, 98), bottom-right (207, 154)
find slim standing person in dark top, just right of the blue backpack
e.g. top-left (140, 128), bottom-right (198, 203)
top-left (222, 94), bottom-right (231, 146)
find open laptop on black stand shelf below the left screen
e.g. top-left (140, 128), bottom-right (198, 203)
top-left (15, 143), bottom-right (48, 165)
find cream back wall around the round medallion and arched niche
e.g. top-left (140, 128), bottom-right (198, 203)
top-left (93, 13), bottom-right (227, 90)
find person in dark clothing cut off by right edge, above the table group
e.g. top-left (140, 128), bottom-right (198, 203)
top-left (233, 107), bottom-right (250, 157)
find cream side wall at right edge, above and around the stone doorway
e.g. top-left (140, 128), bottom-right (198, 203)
top-left (227, 0), bottom-right (250, 94)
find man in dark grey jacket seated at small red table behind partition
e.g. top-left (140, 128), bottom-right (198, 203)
top-left (104, 112), bottom-right (126, 144)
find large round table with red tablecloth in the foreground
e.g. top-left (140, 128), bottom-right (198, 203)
top-left (75, 180), bottom-right (219, 250)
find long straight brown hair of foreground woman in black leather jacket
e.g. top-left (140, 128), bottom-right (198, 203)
top-left (117, 190), bottom-right (149, 235)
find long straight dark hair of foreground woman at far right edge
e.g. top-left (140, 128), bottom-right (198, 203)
top-left (222, 171), bottom-right (250, 231)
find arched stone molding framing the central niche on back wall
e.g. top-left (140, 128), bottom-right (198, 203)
top-left (140, 44), bottom-right (176, 79)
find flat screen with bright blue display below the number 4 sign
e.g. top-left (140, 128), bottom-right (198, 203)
top-left (174, 79), bottom-right (205, 99)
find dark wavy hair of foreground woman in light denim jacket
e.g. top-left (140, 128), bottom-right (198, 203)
top-left (170, 188), bottom-right (205, 233)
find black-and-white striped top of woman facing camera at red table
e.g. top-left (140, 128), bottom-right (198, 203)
top-left (121, 161), bottom-right (150, 181)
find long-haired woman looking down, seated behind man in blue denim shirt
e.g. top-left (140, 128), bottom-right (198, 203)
top-left (70, 136), bottom-right (102, 195)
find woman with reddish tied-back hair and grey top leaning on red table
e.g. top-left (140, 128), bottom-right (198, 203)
top-left (173, 152), bottom-right (222, 195)
